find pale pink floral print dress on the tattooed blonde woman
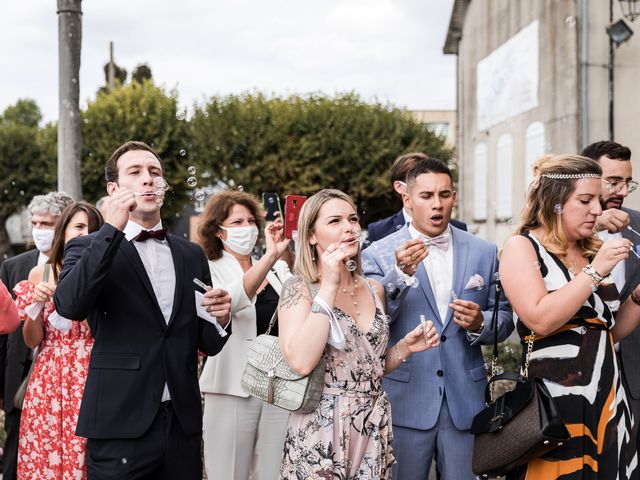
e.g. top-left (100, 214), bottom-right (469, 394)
top-left (280, 284), bottom-right (395, 480)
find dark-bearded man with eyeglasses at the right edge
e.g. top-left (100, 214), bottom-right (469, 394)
top-left (582, 140), bottom-right (640, 479)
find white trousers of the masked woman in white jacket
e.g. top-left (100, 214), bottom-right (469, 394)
top-left (203, 393), bottom-right (289, 480)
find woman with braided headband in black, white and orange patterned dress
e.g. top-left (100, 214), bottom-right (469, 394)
top-left (500, 155), bottom-right (640, 480)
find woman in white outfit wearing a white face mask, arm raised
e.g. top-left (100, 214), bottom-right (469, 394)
top-left (200, 192), bottom-right (291, 480)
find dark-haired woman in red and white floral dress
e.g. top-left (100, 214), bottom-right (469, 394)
top-left (14, 202), bottom-right (103, 480)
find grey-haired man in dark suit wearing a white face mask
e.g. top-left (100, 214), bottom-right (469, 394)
top-left (0, 192), bottom-right (73, 480)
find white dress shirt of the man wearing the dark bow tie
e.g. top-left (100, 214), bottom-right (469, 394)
top-left (124, 220), bottom-right (176, 402)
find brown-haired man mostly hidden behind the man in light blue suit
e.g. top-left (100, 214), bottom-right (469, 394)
top-left (363, 152), bottom-right (467, 248)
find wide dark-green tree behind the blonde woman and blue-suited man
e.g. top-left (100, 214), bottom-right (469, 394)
top-left (190, 93), bottom-right (453, 224)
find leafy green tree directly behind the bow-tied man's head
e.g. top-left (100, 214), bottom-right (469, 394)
top-left (81, 80), bottom-right (188, 224)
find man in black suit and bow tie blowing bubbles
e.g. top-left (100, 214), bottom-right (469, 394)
top-left (54, 142), bottom-right (231, 480)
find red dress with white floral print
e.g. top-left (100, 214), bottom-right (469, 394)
top-left (14, 281), bottom-right (93, 480)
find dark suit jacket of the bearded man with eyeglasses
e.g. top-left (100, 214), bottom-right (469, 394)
top-left (620, 208), bottom-right (640, 399)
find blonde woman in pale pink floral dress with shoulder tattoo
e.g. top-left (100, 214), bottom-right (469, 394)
top-left (278, 190), bottom-right (439, 480)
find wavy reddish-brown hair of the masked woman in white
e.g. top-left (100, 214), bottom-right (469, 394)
top-left (198, 191), bottom-right (264, 260)
